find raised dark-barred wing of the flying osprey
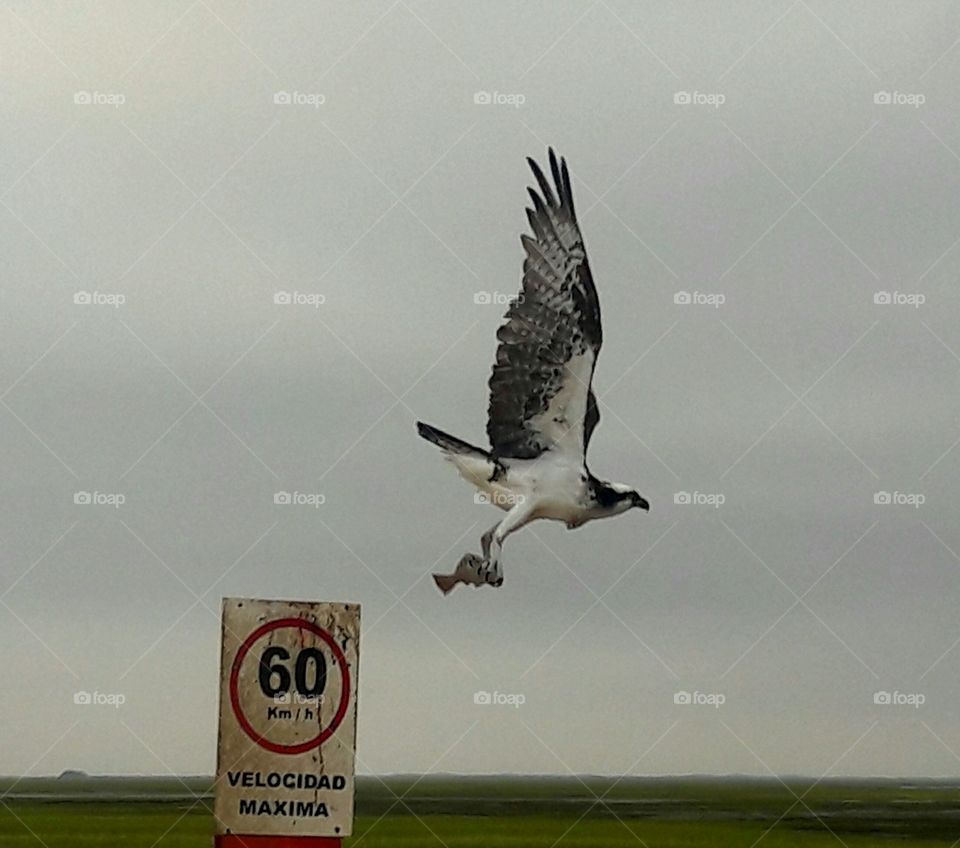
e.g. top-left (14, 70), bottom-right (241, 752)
top-left (487, 149), bottom-right (603, 462)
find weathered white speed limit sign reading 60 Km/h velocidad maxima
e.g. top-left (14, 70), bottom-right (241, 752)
top-left (214, 598), bottom-right (360, 837)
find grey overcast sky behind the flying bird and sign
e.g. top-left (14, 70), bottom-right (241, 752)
top-left (0, 0), bottom-right (960, 776)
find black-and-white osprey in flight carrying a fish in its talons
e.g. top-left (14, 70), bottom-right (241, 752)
top-left (417, 149), bottom-right (650, 594)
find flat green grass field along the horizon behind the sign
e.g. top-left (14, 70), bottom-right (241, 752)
top-left (0, 776), bottom-right (960, 848)
